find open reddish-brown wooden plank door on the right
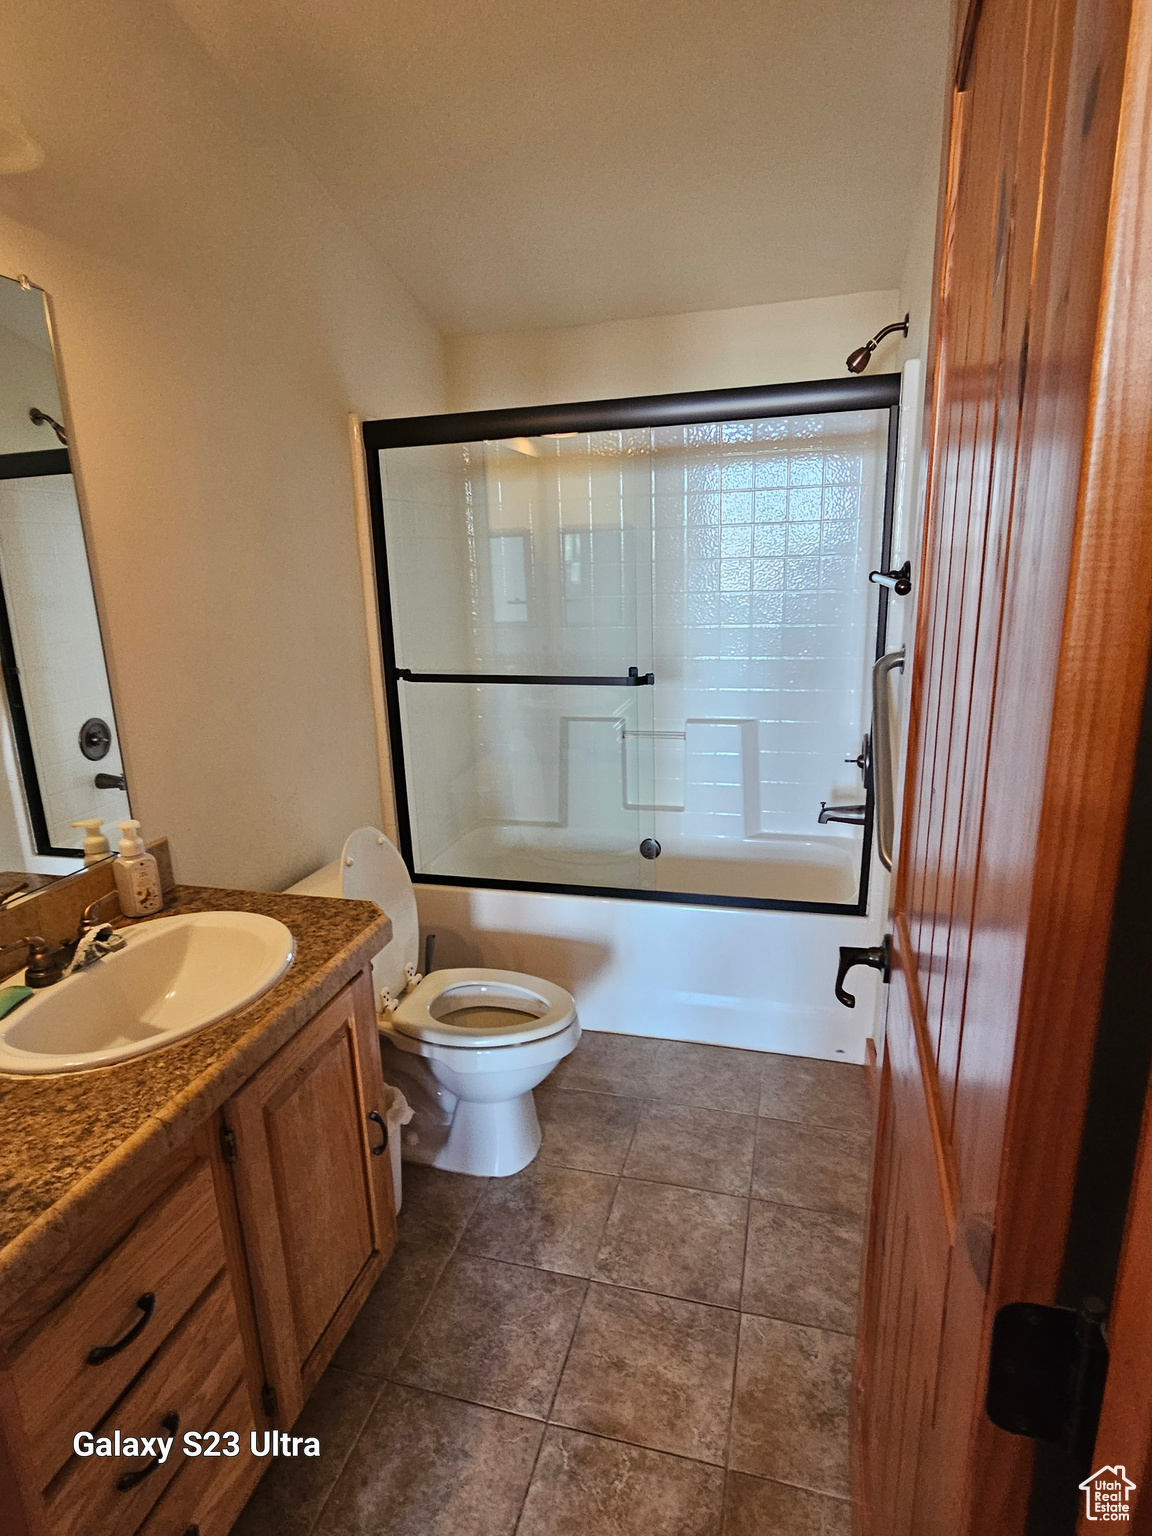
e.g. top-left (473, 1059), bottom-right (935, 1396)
top-left (854, 0), bottom-right (1152, 1536)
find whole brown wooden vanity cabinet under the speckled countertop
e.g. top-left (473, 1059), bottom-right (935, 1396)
top-left (0, 972), bottom-right (396, 1536)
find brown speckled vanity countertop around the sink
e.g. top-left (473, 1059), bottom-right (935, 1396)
top-left (0, 885), bottom-right (392, 1312)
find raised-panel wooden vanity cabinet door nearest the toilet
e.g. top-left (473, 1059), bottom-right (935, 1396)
top-left (226, 972), bottom-right (396, 1427)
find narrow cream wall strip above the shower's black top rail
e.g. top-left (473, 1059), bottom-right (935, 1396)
top-left (444, 289), bottom-right (903, 410)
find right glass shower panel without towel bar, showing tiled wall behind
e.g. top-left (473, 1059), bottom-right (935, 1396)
top-left (651, 409), bottom-right (889, 905)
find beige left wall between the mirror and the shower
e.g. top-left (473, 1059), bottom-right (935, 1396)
top-left (0, 0), bottom-right (442, 888)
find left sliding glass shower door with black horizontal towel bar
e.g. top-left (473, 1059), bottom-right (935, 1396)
top-left (379, 439), bottom-right (654, 889)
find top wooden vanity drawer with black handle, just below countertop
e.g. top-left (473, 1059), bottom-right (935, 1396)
top-left (9, 1160), bottom-right (224, 1487)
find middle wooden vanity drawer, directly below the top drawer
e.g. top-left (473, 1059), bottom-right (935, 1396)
top-left (45, 1275), bottom-right (247, 1536)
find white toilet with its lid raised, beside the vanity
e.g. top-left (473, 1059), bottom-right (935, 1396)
top-left (292, 826), bottom-right (581, 1178)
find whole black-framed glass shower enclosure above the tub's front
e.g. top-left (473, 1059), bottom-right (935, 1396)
top-left (364, 375), bottom-right (900, 914)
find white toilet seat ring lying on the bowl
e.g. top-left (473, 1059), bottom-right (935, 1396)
top-left (389, 966), bottom-right (576, 1051)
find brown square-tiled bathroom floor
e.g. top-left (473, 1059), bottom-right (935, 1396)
top-left (235, 1034), bottom-right (871, 1536)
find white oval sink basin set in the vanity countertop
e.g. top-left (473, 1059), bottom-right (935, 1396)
top-left (0, 912), bottom-right (296, 1077)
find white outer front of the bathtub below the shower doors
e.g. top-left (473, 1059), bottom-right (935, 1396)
top-left (416, 866), bottom-right (883, 1061)
